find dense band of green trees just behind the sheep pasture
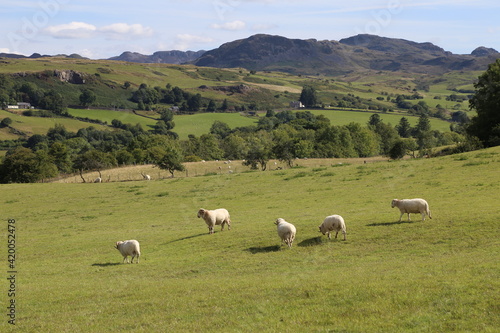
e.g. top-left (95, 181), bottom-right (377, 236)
top-left (0, 110), bottom-right (463, 183)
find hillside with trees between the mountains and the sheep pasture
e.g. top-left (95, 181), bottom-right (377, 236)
top-left (0, 48), bottom-right (498, 183)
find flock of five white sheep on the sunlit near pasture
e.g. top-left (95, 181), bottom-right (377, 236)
top-left (115, 199), bottom-right (432, 264)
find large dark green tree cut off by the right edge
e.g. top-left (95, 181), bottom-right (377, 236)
top-left (467, 59), bottom-right (500, 146)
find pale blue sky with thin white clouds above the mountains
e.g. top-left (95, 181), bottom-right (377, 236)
top-left (0, 0), bottom-right (500, 59)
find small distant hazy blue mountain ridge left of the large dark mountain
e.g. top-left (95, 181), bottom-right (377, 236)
top-left (108, 50), bottom-right (205, 64)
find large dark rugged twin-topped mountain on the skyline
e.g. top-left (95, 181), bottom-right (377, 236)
top-left (192, 34), bottom-right (500, 75)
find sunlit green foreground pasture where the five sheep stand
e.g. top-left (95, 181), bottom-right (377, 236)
top-left (0, 147), bottom-right (500, 332)
